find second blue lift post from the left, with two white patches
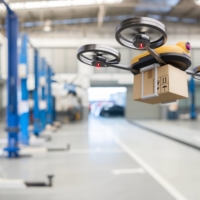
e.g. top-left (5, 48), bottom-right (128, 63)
top-left (19, 34), bottom-right (29, 145)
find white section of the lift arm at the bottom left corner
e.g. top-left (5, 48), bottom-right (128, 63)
top-left (0, 178), bottom-right (26, 189)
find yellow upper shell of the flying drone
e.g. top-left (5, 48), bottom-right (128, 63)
top-left (131, 41), bottom-right (191, 65)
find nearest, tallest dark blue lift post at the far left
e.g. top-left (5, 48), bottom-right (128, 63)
top-left (0, 0), bottom-right (19, 158)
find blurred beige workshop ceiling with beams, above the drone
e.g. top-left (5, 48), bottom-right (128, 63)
top-left (0, 0), bottom-right (200, 33)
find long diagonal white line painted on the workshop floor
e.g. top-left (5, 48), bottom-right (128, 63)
top-left (108, 132), bottom-right (188, 200)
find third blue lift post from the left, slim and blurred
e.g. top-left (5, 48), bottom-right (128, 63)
top-left (33, 49), bottom-right (41, 136)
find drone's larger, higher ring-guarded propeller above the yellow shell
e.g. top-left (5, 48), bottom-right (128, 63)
top-left (115, 17), bottom-right (167, 50)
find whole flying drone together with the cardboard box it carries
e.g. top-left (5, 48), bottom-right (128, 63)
top-left (77, 17), bottom-right (200, 104)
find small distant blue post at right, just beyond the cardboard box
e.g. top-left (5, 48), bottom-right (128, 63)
top-left (189, 77), bottom-right (197, 120)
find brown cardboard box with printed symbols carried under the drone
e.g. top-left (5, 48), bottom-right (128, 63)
top-left (133, 65), bottom-right (188, 104)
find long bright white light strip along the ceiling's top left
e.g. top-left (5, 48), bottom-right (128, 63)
top-left (0, 0), bottom-right (123, 10)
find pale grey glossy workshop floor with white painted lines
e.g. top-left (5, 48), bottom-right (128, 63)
top-left (0, 117), bottom-right (200, 200)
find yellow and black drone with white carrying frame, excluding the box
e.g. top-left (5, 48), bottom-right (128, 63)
top-left (77, 17), bottom-right (200, 104)
